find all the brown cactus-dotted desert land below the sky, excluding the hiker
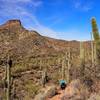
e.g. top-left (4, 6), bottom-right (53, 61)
top-left (0, 18), bottom-right (100, 100)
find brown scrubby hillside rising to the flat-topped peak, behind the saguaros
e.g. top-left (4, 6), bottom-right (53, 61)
top-left (0, 19), bottom-right (98, 100)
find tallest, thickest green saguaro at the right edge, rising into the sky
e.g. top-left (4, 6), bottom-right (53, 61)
top-left (91, 18), bottom-right (100, 64)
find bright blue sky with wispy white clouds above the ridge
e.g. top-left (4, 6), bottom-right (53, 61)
top-left (0, 0), bottom-right (100, 41)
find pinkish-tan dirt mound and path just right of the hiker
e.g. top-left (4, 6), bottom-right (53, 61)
top-left (47, 80), bottom-right (83, 100)
